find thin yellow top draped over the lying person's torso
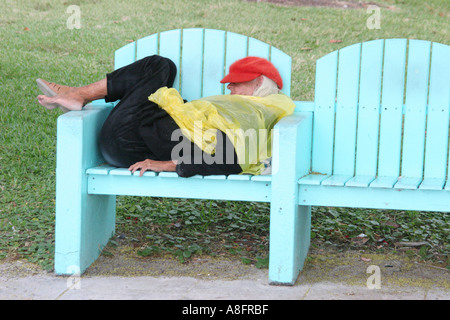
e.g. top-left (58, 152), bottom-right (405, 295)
top-left (149, 87), bottom-right (295, 175)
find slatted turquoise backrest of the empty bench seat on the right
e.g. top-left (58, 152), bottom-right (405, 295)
top-left (311, 39), bottom-right (450, 179)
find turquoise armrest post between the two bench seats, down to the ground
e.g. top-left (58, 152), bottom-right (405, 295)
top-left (269, 112), bottom-right (312, 285)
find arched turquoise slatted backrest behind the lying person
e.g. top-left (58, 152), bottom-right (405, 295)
top-left (114, 28), bottom-right (292, 100)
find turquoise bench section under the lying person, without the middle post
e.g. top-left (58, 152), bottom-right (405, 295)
top-left (55, 29), bottom-right (291, 284)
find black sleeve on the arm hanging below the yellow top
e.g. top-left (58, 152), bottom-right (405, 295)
top-left (176, 130), bottom-right (242, 177)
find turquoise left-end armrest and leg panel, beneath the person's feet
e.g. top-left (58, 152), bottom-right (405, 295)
top-left (55, 108), bottom-right (116, 275)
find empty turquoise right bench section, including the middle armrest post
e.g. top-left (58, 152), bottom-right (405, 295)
top-left (269, 39), bottom-right (450, 283)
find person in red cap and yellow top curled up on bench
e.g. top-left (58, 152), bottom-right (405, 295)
top-left (37, 55), bottom-right (295, 177)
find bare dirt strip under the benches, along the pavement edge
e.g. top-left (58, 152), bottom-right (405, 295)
top-left (79, 246), bottom-right (450, 290)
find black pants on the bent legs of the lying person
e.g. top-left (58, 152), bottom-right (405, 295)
top-left (100, 56), bottom-right (178, 167)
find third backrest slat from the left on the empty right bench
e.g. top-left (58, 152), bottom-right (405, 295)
top-left (355, 40), bottom-right (384, 179)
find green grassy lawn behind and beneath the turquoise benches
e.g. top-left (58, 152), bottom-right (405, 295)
top-left (0, 0), bottom-right (450, 270)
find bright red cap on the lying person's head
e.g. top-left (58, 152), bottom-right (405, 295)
top-left (220, 57), bottom-right (283, 90)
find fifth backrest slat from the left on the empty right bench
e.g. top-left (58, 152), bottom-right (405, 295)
top-left (401, 40), bottom-right (431, 177)
